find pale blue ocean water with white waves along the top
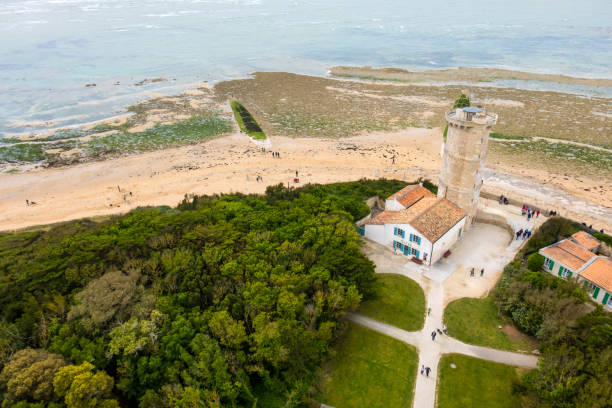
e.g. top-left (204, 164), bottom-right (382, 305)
top-left (0, 0), bottom-right (612, 136)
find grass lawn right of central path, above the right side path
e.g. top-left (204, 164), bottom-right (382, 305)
top-left (444, 298), bottom-right (537, 351)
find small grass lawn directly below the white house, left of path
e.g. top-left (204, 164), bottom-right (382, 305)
top-left (357, 273), bottom-right (425, 331)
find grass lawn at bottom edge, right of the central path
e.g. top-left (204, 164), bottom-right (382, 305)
top-left (438, 354), bottom-right (521, 408)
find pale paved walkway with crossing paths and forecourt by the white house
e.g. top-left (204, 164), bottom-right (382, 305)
top-left (348, 218), bottom-right (538, 408)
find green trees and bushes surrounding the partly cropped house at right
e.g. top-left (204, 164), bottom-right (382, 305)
top-left (492, 217), bottom-right (612, 408)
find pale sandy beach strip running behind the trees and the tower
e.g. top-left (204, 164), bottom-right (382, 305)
top-left (0, 128), bottom-right (612, 231)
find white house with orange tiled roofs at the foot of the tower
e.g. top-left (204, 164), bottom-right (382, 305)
top-left (364, 184), bottom-right (466, 265)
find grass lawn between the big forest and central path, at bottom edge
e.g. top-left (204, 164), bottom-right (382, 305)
top-left (315, 323), bottom-right (418, 408)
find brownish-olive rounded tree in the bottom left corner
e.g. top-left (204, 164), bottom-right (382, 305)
top-left (0, 349), bottom-right (66, 401)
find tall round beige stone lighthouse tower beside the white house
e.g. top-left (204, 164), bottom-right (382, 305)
top-left (438, 107), bottom-right (497, 229)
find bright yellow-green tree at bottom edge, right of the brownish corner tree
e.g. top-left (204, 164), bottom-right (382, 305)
top-left (53, 362), bottom-right (119, 408)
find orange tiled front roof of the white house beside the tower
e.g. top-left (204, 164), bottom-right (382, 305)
top-left (368, 194), bottom-right (465, 242)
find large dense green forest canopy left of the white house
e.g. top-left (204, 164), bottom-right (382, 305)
top-left (0, 180), bottom-right (406, 408)
